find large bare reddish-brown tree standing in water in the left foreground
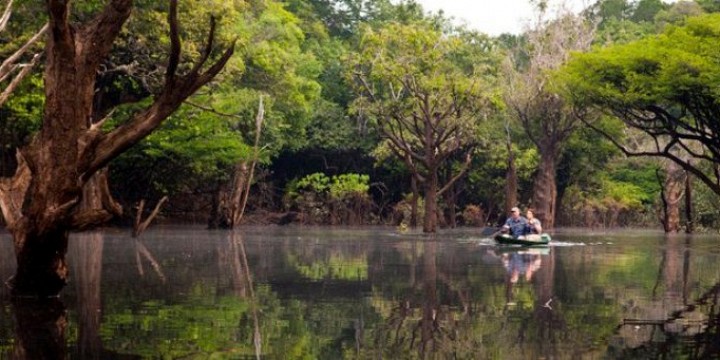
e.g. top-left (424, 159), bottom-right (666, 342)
top-left (0, 0), bottom-right (234, 296)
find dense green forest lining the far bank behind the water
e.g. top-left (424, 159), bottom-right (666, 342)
top-left (0, 0), bottom-right (720, 232)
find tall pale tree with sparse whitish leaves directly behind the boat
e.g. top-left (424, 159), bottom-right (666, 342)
top-left (506, 8), bottom-right (594, 229)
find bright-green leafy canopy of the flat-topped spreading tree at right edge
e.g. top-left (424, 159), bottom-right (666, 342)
top-left (561, 15), bottom-right (720, 107)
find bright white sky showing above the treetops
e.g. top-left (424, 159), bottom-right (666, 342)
top-left (416, 0), bottom-right (594, 36)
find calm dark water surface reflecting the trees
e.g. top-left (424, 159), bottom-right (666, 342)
top-left (0, 226), bottom-right (720, 359)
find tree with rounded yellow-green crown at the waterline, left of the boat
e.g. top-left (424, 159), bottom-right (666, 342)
top-left (350, 24), bottom-right (492, 232)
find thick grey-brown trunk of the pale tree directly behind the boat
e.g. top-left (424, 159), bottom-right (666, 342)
top-left (532, 151), bottom-right (557, 229)
